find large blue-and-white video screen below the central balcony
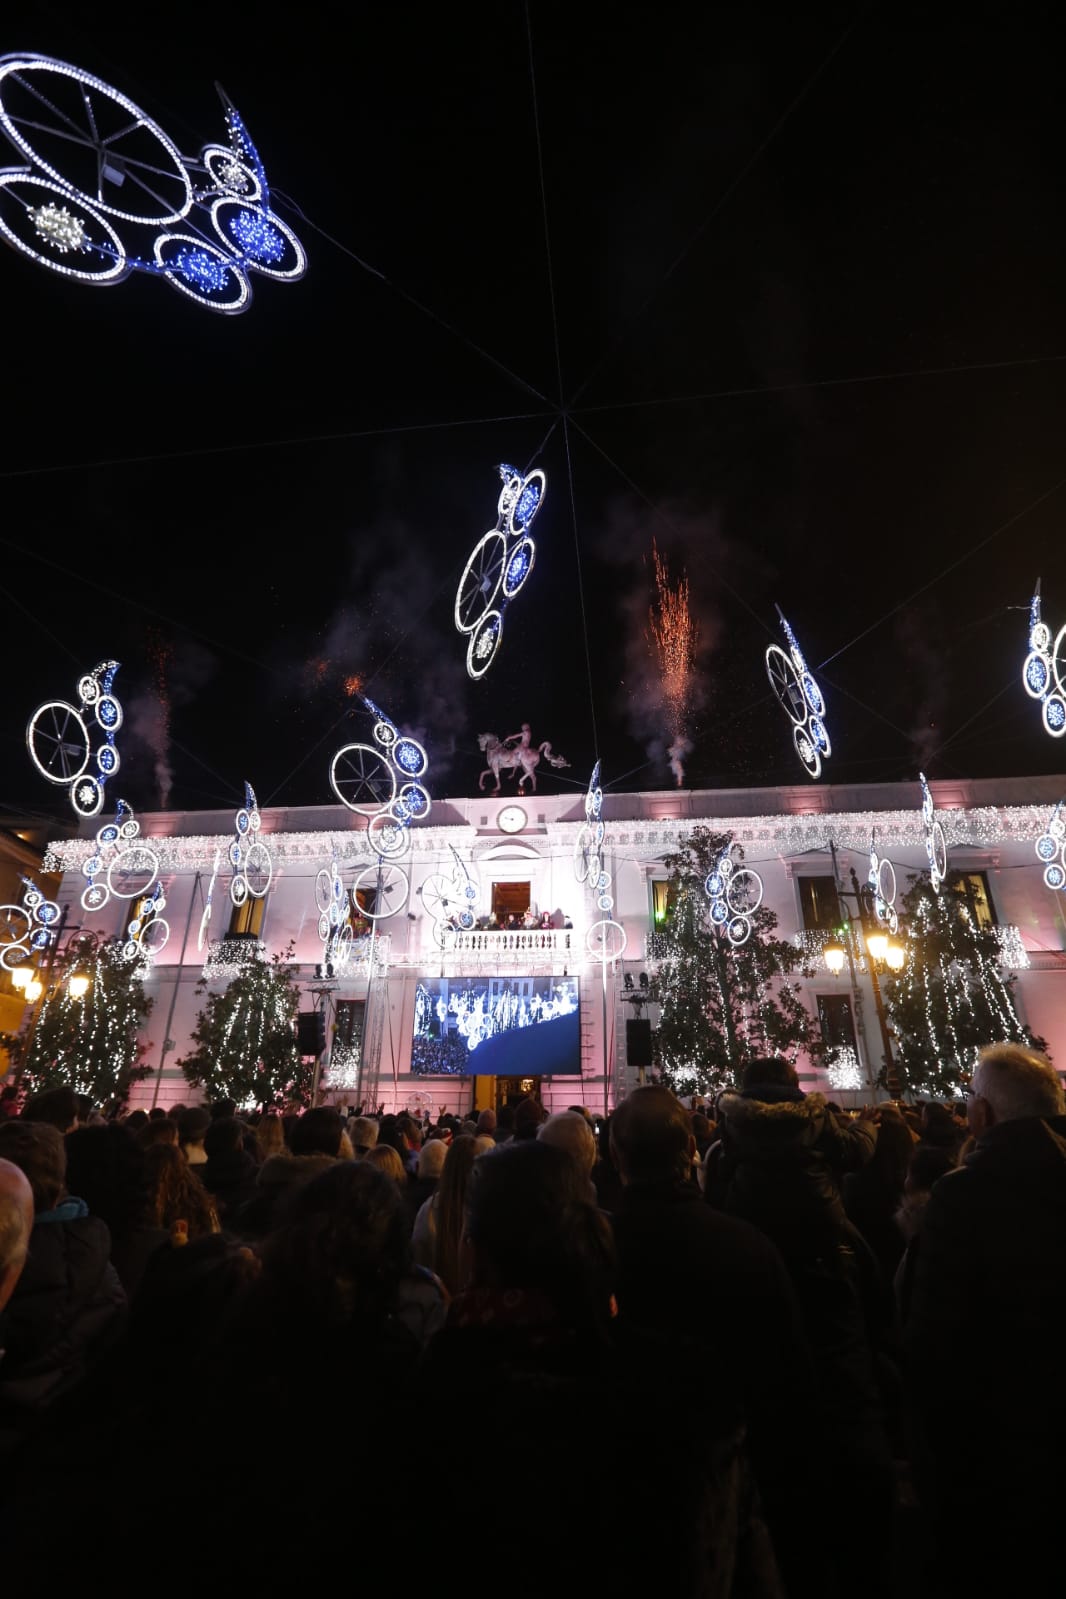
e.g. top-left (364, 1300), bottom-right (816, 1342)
top-left (411, 977), bottom-right (582, 1078)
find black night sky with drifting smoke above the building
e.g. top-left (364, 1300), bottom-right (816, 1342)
top-left (0, 0), bottom-right (1066, 817)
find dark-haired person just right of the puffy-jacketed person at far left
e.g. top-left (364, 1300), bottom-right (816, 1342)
top-left (66, 1121), bottom-right (169, 1303)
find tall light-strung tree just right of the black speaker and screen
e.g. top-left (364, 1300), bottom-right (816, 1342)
top-left (652, 827), bottom-right (823, 1094)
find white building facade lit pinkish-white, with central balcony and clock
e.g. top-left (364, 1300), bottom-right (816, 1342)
top-left (45, 777), bottom-right (1066, 1113)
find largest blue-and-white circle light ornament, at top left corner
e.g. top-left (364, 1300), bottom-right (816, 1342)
top-left (0, 53), bottom-right (307, 315)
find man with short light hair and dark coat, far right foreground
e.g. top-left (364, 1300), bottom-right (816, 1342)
top-left (903, 1044), bottom-right (1066, 1596)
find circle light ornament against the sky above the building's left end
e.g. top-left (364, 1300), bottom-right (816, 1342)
top-left (26, 660), bottom-right (121, 820)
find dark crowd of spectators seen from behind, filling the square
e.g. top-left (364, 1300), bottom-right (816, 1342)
top-left (0, 1044), bottom-right (1066, 1599)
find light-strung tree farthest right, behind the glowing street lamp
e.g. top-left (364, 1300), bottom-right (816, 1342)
top-left (885, 871), bottom-right (1047, 1097)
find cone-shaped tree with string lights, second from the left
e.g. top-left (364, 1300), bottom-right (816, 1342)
top-left (177, 945), bottom-right (313, 1107)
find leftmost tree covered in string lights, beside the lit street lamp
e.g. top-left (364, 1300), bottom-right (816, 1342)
top-left (10, 940), bottom-right (155, 1105)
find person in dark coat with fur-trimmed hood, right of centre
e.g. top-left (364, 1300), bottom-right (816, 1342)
top-left (705, 1057), bottom-right (895, 1596)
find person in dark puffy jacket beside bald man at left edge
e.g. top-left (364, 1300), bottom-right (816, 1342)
top-left (0, 1119), bottom-right (128, 1460)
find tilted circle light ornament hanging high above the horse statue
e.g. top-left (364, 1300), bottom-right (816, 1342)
top-left (455, 462), bottom-right (548, 681)
